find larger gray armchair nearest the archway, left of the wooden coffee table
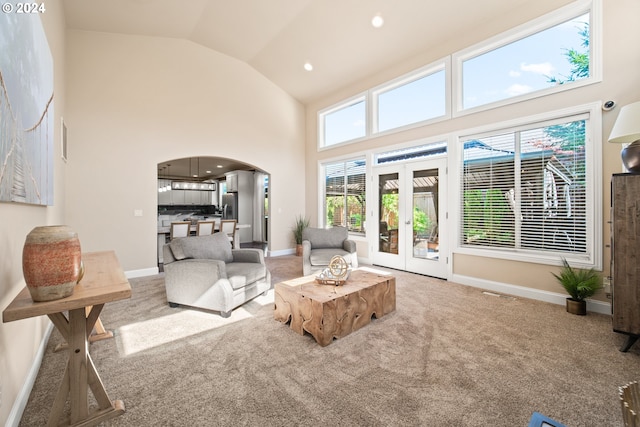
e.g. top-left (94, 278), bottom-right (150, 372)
top-left (163, 233), bottom-right (271, 317)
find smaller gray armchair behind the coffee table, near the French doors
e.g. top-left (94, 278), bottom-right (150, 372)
top-left (302, 227), bottom-right (358, 276)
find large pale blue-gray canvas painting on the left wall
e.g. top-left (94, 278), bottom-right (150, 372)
top-left (0, 13), bottom-right (54, 205)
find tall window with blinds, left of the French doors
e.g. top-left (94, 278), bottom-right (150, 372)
top-left (324, 159), bottom-right (366, 233)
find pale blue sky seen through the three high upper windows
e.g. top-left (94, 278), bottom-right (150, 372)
top-left (324, 14), bottom-right (589, 145)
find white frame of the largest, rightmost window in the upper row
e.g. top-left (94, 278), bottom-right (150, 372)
top-left (452, 0), bottom-right (602, 117)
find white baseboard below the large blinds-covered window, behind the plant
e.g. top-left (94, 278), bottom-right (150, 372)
top-left (451, 274), bottom-right (611, 315)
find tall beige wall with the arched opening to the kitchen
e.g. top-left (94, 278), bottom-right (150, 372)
top-left (65, 31), bottom-right (304, 271)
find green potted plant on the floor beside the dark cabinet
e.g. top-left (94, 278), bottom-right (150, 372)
top-left (551, 258), bottom-right (602, 315)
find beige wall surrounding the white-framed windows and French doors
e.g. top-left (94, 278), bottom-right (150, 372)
top-left (306, 0), bottom-right (640, 299)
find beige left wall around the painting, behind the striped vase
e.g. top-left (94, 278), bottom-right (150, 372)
top-left (0, 2), bottom-right (66, 425)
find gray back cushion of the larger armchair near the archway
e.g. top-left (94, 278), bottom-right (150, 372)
top-left (169, 233), bottom-right (233, 262)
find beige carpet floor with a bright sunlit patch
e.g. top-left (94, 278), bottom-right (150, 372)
top-left (20, 256), bottom-right (640, 427)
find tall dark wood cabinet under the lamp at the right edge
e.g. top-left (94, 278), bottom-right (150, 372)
top-left (611, 173), bottom-right (640, 351)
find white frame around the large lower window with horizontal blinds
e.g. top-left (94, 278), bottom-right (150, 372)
top-left (449, 102), bottom-right (602, 270)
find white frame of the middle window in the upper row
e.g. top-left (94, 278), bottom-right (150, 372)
top-left (369, 56), bottom-right (451, 135)
